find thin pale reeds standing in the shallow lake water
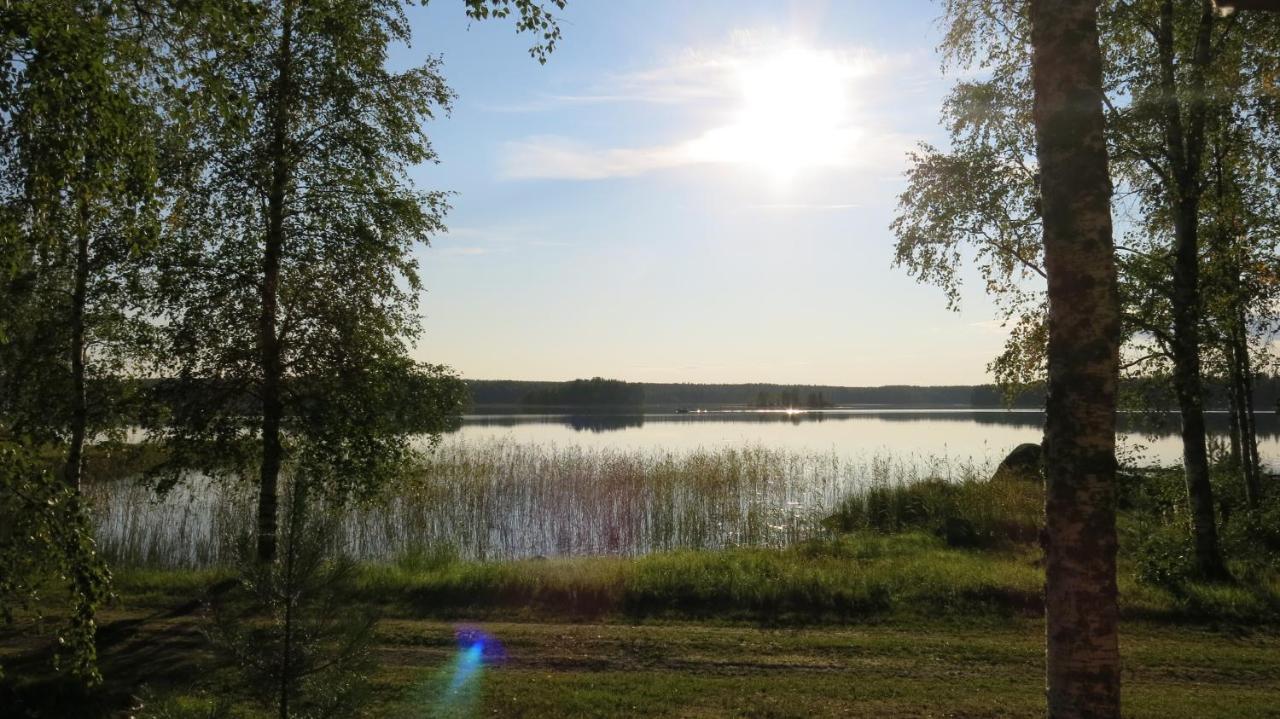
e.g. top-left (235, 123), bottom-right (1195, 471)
top-left (91, 440), bottom-right (989, 568)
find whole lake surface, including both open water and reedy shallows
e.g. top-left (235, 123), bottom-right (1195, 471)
top-left (88, 409), bottom-right (1280, 567)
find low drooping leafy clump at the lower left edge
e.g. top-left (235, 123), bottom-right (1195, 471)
top-left (0, 443), bottom-right (111, 684)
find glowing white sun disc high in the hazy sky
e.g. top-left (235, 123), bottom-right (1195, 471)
top-left (695, 47), bottom-right (856, 179)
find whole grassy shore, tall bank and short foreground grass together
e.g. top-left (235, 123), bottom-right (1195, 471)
top-left (0, 532), bottom-right (1280, 719)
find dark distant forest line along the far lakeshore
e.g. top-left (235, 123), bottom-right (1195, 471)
top-left (466, 376), bottom-right (1280, 412)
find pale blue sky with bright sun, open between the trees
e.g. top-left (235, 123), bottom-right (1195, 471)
top-left (393, 0), bottom-right (1005, 385)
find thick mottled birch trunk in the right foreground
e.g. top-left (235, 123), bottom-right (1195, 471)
top-left (1030, 0), bottom-right (1120, 718)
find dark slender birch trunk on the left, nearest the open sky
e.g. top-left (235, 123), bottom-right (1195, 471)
top-left (257, 3), bottom-right (293, 562)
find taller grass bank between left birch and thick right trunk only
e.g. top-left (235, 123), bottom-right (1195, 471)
top-left (348, 533), bottom-right (1041, 622)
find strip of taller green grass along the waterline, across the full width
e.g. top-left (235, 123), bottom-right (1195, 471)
top-left (107, 532), bottom-right (1280, 626)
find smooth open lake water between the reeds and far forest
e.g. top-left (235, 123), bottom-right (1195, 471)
top-left (456, 409), bottom-right (1280, 470)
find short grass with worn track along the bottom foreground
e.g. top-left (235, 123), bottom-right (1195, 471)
top-left (5, 608), bottom-right (1280, 719)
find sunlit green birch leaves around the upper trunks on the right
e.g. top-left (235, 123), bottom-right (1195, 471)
top-left (891, 0), bottom-right (1280, 390)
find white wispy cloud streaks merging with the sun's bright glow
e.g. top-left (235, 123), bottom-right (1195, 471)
top-left (499, 32), bottom-right (914, 180)
